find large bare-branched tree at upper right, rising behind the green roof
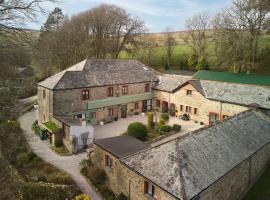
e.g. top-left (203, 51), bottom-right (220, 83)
top-left (213, 0), bottom-right (270, 72)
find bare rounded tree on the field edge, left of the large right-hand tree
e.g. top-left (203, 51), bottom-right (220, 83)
top-left (183, 13), bottom-right (210, 57)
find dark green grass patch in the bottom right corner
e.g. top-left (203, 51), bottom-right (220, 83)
top-left (243, 166), bottom-right (270, 200)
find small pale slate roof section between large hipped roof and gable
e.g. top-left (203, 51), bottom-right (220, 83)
top-left (154, 74), bottom-right (191, 92)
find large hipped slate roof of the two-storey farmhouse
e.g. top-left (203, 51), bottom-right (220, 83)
top-left (38, 59), bottom-right (158, 90)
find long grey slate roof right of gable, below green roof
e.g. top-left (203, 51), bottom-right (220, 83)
top-left (200, 80), bottom-right (270, 109)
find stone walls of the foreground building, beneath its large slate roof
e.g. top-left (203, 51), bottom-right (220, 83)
top-left (91, 141), bottom-right (270, 200)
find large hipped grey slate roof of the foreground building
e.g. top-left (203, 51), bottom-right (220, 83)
top-left (121, 111), bottom-right (270, 199)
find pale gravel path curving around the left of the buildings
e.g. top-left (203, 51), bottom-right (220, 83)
top-left (19, 110), bottom-right (102, 200)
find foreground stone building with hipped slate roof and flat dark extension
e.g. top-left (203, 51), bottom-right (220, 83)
top-left (91, 110), bottom-right (270, 200)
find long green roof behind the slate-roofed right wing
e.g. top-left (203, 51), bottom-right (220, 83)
top-left (193, 70), bottom-right (270, 86)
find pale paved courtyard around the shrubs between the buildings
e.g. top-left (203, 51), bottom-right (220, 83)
top-left (94, 115), bottom-right (203, 141)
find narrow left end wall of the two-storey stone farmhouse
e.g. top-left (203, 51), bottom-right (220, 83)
top-left (37, 86), bottom-right (53, 125)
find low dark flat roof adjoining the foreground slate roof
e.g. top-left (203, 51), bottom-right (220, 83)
top-left (94, 135), bottom-right (149, 158)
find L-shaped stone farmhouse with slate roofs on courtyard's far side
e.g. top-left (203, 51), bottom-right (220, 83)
top-left (38, 59), bottom-right (270, 151)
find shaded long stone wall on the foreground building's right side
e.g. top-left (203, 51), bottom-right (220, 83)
top-left (196, 144), bottom-right (270, 200)
